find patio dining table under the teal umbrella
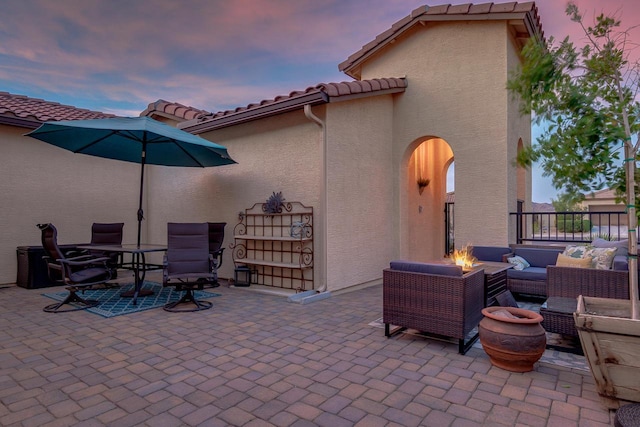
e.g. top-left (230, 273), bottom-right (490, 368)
top-left (77, 243), bottom-right (167, 305)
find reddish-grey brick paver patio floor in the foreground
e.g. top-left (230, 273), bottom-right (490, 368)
top-left (0, 273), bottom-right (613, 427)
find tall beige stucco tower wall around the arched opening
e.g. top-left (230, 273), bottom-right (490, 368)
top-left (362, 21), bottom-right (528, 252)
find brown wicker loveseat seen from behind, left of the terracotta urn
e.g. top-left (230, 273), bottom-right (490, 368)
top-left (382, 261), bottom-right (485, 354)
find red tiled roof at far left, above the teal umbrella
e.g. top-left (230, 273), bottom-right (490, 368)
top-left (0, 92), bottom-right (115, 129)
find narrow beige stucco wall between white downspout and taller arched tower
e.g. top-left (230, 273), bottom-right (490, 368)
top-left (327, 96), bottom-right (396, 291)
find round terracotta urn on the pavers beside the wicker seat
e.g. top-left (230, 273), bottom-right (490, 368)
top-left (478, 307), bottom-right (547, 372)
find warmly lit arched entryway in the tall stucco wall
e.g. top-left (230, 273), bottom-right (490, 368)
top-left (405, 136), bottom-right (453, 261)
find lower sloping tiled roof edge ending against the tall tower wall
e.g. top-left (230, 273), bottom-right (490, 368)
top-left (178, 78), bottom-right (407, 134)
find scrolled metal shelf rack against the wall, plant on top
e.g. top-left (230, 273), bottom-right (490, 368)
top-left (229, 200), bottom-right (314, 290)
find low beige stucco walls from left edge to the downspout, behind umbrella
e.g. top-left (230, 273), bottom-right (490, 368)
top-left (0, 111), bottom-right (322, 287)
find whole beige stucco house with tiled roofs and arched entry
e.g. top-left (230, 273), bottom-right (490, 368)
top-left (0, 2), bottom-right (542, 291)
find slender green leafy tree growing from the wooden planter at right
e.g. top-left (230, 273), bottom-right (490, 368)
top-left (507, 2), bottom-right (640, 319)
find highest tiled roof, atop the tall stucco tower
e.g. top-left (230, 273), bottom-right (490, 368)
top-left (338, 2), bottom-right (544, 79)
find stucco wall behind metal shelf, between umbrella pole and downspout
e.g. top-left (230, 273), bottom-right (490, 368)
top-left (188, 110), bottom-right (324, 288)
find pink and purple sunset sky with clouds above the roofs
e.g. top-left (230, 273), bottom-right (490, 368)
top-left (0, 0), bottom-right (640, 202)
